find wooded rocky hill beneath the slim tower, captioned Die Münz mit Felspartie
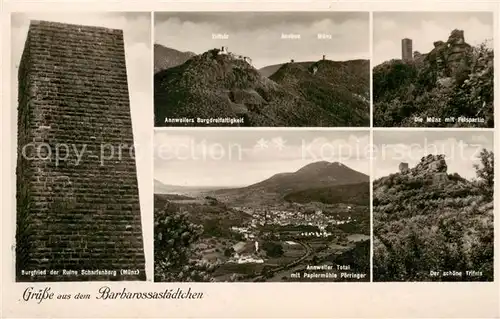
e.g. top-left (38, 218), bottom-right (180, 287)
top-left (373, 30), bottom-right (494, 127)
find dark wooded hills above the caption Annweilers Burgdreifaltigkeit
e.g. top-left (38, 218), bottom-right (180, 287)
top-left (154, 49), bottom-right (369, 126)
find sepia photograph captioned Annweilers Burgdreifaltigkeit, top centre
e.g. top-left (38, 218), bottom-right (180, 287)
top-left (154, 12), bottom-right (370, 127)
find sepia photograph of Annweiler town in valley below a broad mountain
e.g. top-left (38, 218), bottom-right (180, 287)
top-left (154, 129), bottom-right (370, 282)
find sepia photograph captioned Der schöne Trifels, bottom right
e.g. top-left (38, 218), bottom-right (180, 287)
top-left (373, 131), bottom-right (494, 282)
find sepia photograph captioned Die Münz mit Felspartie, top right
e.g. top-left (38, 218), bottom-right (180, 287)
top-left (372, 11), bottom-right (494, 128)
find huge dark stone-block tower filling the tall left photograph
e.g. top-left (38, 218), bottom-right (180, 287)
top-left (16, 21), bottom-right (146, 281)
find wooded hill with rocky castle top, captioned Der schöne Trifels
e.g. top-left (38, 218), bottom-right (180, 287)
top-left (373, 150), bottom-right (493, 281)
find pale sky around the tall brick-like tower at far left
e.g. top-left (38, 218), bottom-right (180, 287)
top-left (11, 13), bottom-right (153, 282)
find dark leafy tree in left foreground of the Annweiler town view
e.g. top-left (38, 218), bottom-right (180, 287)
top-left (154, 204), bottom-right (214, 282)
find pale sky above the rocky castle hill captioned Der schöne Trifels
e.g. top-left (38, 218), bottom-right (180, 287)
top-left (373, 130), bottom-right (493, 179)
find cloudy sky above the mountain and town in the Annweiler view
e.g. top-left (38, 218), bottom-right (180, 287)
top-left (154, 129), bottom-right (370, 186)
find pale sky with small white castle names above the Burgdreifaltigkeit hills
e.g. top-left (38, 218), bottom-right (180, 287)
top-left (154, 12), bottom-right (369, 68)
